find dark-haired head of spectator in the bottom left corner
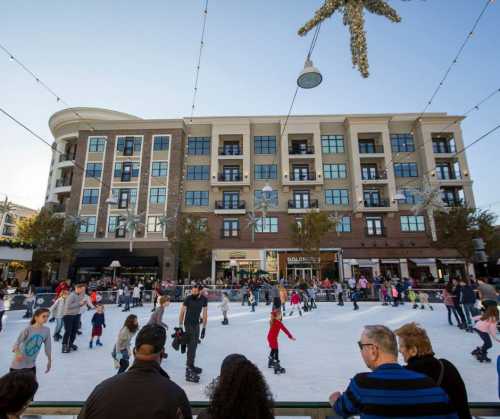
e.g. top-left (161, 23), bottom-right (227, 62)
top-left (0, 371), bottom-right (38, 419)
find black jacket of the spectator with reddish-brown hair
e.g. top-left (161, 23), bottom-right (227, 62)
top-left (406, 355), bottom-right (471, 419)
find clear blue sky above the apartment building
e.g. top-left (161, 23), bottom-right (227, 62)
top-left (0, 0), bottom-right (500, 214)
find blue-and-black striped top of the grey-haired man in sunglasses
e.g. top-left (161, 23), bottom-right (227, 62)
top-left (333, 364), bottom-right (458, 419)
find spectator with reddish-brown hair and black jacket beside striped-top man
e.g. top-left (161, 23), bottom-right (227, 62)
top-left (394, 323), bottom-right (471, 419)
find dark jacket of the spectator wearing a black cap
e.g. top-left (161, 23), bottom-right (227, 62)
top-left (78, 360), bottom-right (193, 419)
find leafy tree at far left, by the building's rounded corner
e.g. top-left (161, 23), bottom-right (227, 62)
top-left (17, 208), bottom-right (78, 284)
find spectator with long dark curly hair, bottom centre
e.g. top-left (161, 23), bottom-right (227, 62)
top-left (198, 354), bottom-right (274, 419)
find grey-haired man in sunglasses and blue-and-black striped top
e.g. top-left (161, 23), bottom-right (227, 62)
top-left (330, 325), bottom-right (458, 419)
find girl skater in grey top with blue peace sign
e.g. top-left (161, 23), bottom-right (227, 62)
top-left (10, 308), bottom-right (52, 375)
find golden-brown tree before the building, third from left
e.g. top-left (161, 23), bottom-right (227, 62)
top-left (290, 211), bottom-right (336, 280)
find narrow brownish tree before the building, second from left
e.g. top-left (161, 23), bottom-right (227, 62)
top-left (170, 215), bottom-right (211, 280)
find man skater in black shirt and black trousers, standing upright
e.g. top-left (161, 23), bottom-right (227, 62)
top-left (179, 285), bottom-right (208, 383)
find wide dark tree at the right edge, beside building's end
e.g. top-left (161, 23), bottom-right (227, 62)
top-left (435, 207), bottom-right (500, 263)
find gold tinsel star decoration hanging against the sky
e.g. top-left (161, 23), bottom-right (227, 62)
top-left (298, 0), bottom-right (401, 77)
